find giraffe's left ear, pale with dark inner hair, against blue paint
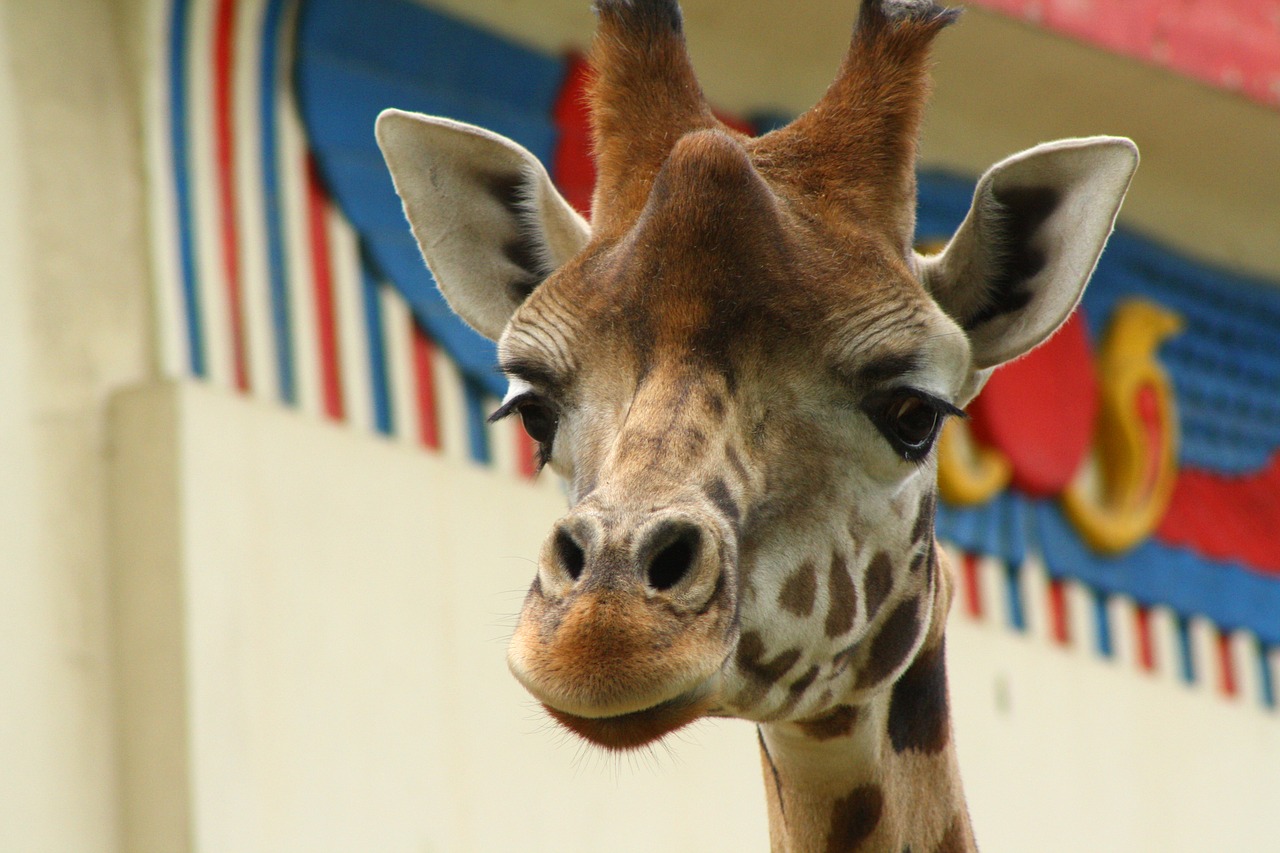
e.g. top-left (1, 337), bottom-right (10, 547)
top-left (376, 110), bottom-right (591, 339)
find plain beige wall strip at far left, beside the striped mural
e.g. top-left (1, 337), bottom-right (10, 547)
top-left (0, 0), bottom-right (147, 853)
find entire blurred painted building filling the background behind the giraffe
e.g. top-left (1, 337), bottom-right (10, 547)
top-left (0, 0), bottom-right (1280, 853)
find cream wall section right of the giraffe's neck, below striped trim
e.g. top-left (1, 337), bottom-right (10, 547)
top-left (947, 613), bottom-right (1280, 853)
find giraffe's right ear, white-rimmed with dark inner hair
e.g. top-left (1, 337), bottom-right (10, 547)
top-left (919, 136), bottom-right (1138, 370)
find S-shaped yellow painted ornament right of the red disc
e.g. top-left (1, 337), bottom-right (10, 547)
top-left (1062, 300), bottom-right (1183, 553)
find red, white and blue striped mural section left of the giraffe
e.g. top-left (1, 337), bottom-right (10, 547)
top-left (148, 0), bottom-right (504, 471)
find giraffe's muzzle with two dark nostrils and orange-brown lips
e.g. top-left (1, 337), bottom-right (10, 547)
top-left (508, 510), bottom-right (736, 748)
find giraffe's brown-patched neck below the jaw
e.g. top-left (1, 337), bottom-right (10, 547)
top-left (759, 548), bottom-right (977, 853)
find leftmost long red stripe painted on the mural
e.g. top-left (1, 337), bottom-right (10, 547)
top-left (214, 0), bottom-right (248, 391)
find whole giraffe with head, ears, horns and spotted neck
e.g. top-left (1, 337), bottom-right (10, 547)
top-left (376, 0), bottom-right (1138, 853)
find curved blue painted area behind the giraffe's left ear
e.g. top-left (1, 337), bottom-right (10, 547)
top-left (296, 0), bottom-right (564, 396)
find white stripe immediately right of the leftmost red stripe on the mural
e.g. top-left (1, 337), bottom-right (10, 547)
top-left (234, 0), bottom-right (279, 401)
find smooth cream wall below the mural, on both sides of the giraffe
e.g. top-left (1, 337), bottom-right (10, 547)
top-left (113, 384), bottom-right (1280, 853)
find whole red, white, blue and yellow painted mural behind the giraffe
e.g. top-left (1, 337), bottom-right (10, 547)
top-left (157, 0), bottom-right (1280, 708)
